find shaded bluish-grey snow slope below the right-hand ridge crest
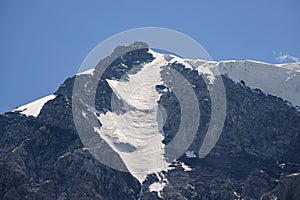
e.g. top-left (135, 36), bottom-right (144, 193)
top-left (211, 61), bottom-right (300, 106)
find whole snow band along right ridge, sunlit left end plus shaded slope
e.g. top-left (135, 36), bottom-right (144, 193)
top-left (171, 57), bottom-right (300, 106)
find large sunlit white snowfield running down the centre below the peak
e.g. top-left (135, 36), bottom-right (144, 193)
top-left (95, 52), bottom-right (169, 183)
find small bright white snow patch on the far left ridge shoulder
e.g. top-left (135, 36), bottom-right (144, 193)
top-left (13, 94), bottom-right (56, 117)
